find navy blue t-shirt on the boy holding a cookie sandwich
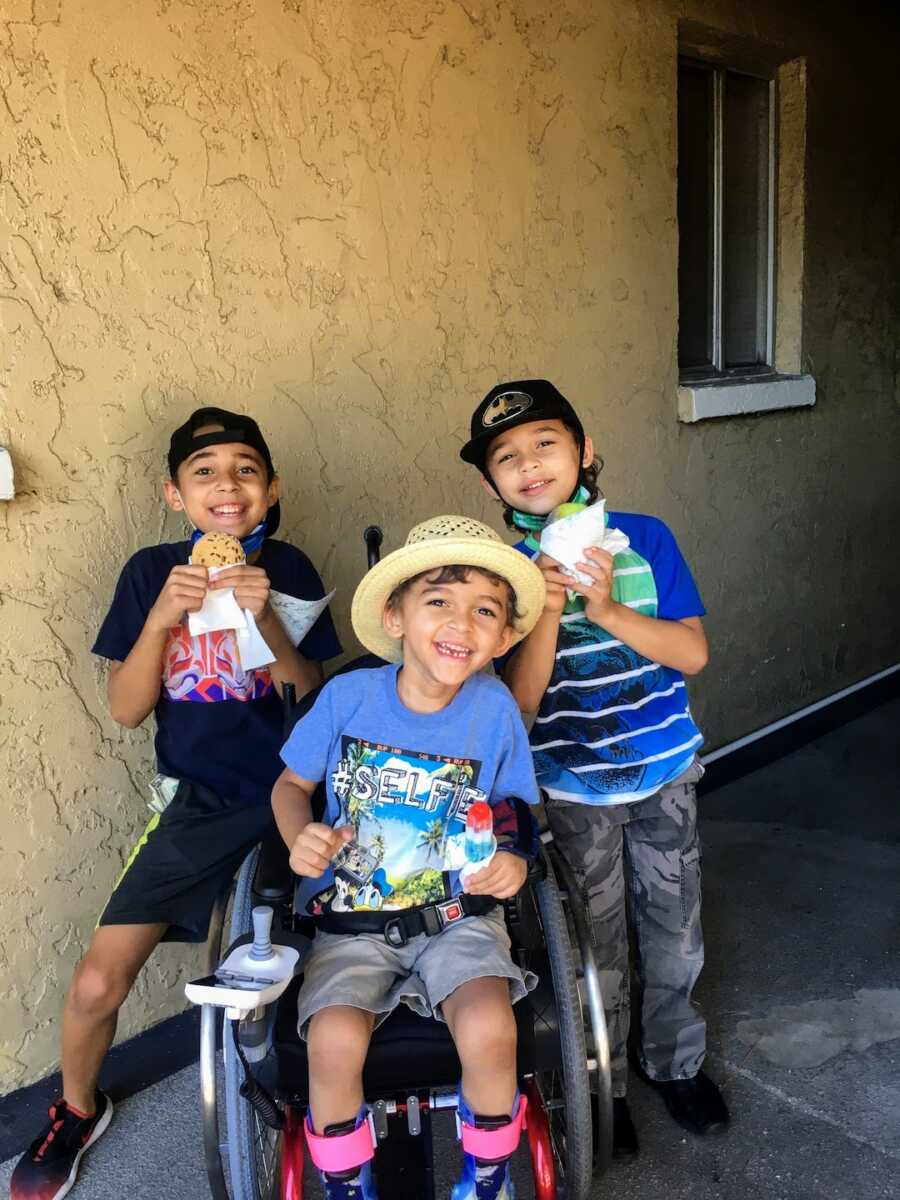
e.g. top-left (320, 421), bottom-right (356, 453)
top-left (94, 539), bottom-right (341, 804)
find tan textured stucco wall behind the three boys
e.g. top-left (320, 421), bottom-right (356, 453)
top-left (0, 0), bottom-right (900, 1091)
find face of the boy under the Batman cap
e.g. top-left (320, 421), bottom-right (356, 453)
top-left (482, 418), bottom-right (594, 516)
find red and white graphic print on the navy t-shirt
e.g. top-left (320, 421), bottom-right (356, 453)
top-left (162, 620), bottom-right (275, 704)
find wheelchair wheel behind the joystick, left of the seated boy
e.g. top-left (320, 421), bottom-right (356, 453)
top-left (222, 850), bottom-right (281, 1200)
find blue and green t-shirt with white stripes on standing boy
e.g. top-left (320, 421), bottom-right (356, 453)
top-left (512, 512), bottom-right (706, 804)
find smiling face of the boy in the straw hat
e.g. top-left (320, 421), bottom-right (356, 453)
top-left (384, 566), bottom-right (512, 691)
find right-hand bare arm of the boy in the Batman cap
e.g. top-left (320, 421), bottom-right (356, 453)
top-left (571, 550), bottom-right (709, 676)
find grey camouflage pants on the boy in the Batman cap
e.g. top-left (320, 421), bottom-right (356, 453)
top-left (547, 762), bottom-right (706, 1096)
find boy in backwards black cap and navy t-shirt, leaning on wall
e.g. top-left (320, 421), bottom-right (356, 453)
top-left (11, 408), bottom-right (341, 1200)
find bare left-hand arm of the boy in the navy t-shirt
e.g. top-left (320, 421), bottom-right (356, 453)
top-left (107, 566), bottom-right (209, 730)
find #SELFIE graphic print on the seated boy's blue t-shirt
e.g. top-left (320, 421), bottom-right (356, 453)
top-left (308, 734), bottom-right (487, 914)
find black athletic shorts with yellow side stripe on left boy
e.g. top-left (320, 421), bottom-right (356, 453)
top-left (97, 779), bottom-right (275, 942)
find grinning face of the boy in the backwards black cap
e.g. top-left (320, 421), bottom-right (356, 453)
top-left (163, 426), bottom-right (281, 538)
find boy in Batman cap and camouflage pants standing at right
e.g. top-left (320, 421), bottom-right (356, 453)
top-left (461, 379), bottom-right (728, 1157)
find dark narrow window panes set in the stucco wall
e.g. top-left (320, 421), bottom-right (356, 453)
top-left (678, 59), bottom-right (775, 382)
